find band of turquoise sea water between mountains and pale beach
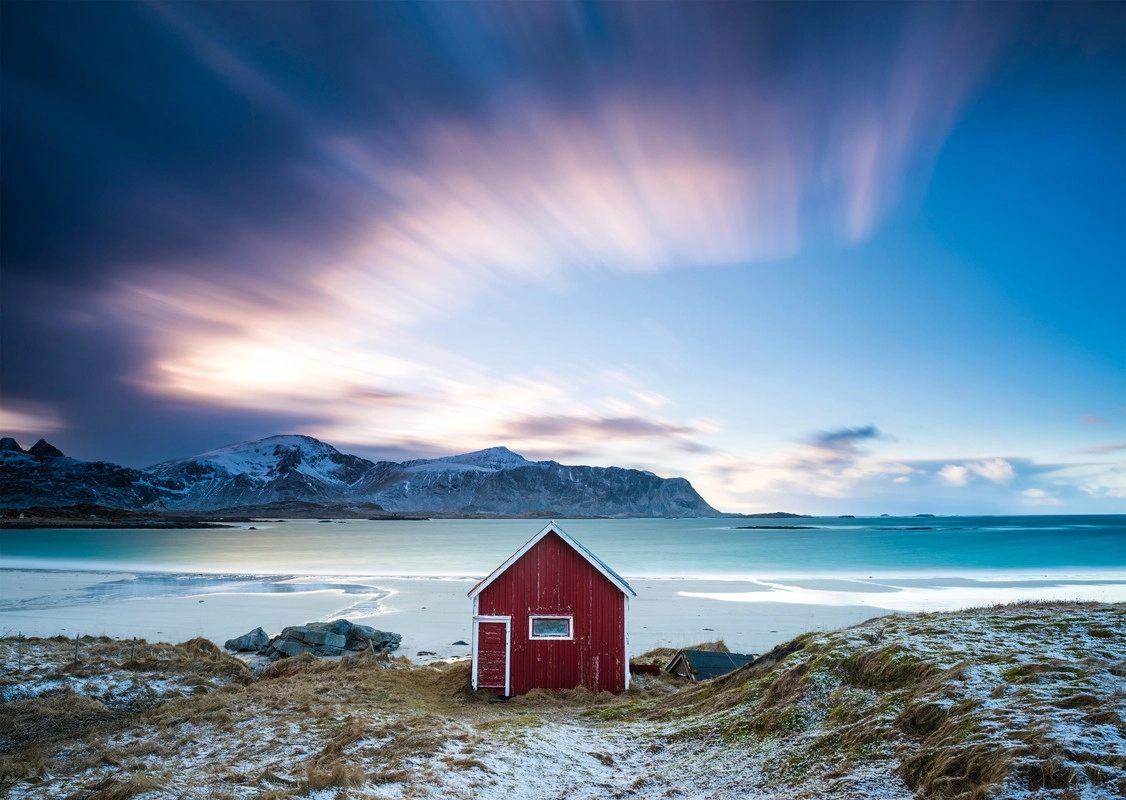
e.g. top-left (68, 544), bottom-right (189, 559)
top-left (0, 515), bottom-right (1126, 580)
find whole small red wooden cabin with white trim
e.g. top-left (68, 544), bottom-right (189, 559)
top-left (470, 522), bottom-right (637, 697)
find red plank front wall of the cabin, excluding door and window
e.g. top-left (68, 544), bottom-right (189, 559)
top-left (476, 533), bottom-right (626, 695)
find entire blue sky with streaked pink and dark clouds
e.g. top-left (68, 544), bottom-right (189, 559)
top-left (0, 0), bottom-right (1126, 515)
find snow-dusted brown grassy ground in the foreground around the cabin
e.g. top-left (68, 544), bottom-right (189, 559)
top-left (0, 604), bottom-right (1126, 800)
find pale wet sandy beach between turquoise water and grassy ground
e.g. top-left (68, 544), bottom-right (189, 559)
top-left (8, 569), bottom-right (1126, 660)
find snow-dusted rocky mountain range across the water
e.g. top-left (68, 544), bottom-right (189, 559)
top-left (0, 436), bottom-right (718, 517)
